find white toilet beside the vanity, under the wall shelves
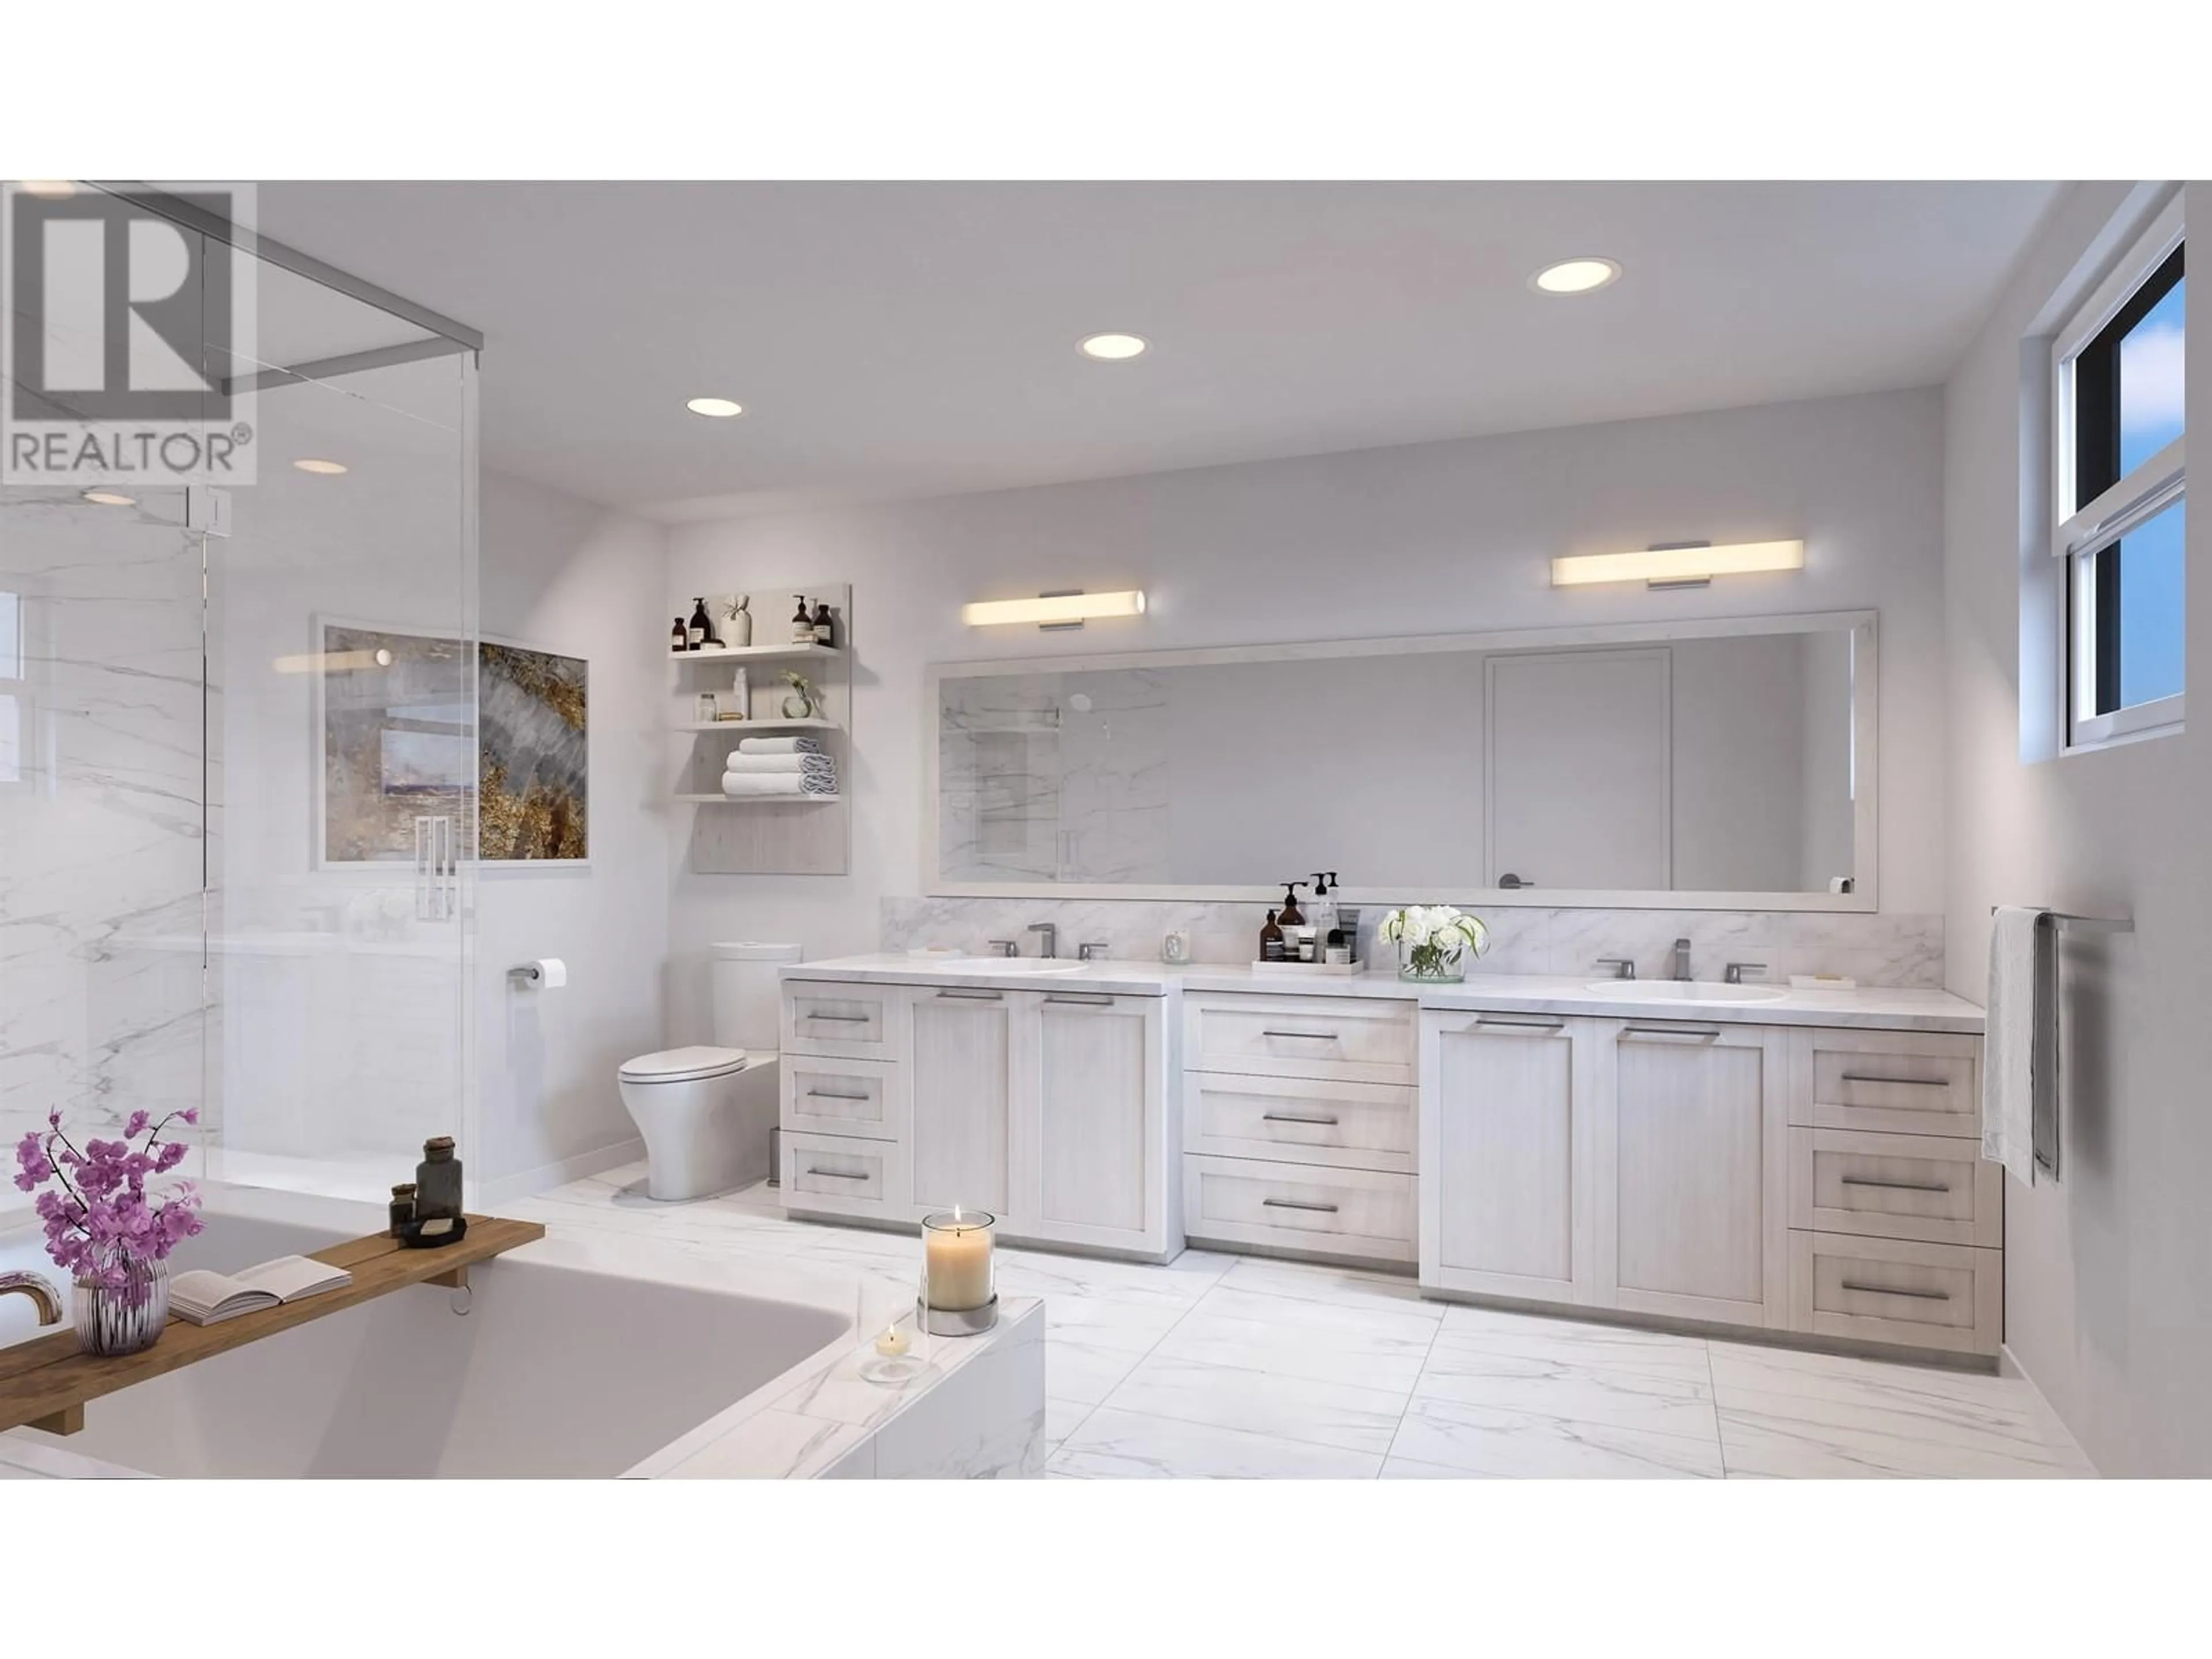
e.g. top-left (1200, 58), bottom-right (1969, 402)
top-left (617, 942), bottom-right (801, 1201)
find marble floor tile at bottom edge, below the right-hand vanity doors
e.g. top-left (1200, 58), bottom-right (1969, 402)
top-left (1389, 1396), bottom-right (1721, 1480)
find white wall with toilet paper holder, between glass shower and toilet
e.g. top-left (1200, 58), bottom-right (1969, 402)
top-left (474, 474), bottom-right (671, 1199)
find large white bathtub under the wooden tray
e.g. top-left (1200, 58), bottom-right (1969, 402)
top-left (0, 1192), bottom-right (1042, 1478)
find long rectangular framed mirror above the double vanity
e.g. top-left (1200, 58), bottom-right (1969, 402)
top-left (922, 611), bottom-right (1878, 911)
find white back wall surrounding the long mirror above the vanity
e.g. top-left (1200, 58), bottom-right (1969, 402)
top-left (664, 389), bottom-right (1944, 1040)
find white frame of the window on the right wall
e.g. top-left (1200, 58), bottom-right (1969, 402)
top-left (2051, 190), bottom-right (2188, 754)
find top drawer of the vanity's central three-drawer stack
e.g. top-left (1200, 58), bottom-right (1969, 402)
top-left (1183, 995), bottom-right (1416, 1084)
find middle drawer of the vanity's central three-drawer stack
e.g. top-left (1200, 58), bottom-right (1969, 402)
top-left (1183, 1071), bottom-right (1420, 1175)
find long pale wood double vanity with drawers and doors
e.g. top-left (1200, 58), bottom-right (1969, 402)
top-left (781, 958), bottom-right (2004, 1356)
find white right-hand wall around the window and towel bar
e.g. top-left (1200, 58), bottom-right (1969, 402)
top-left (1946, 184), bottom-right (2212, 1475)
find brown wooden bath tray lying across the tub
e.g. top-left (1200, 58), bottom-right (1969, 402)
top-left (0, 1214), bottom-right (546, 1433)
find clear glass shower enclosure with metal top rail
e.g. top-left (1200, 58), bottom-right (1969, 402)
top-left (0, 186), bottom-right (480, 1247)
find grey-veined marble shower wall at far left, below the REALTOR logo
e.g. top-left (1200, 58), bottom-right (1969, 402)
top-left (0, 500), bottom-right (210, 1176)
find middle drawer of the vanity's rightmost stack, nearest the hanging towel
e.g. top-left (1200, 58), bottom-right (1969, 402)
top-left (1790, 1128), bottom-right (2004, 1250)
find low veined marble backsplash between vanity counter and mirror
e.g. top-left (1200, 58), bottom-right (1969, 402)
top-left (880, 898), bottom-right (1942, 991)
